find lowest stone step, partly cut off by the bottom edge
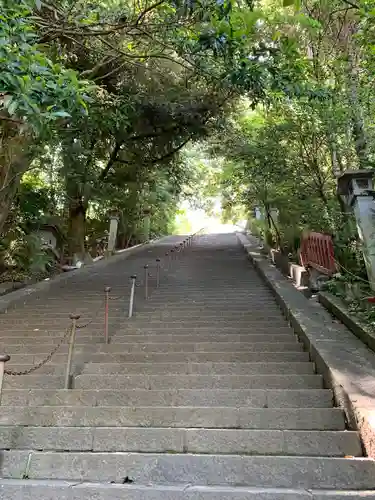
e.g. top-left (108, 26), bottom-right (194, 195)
top-left (0, 479), bottom-right (375, 500)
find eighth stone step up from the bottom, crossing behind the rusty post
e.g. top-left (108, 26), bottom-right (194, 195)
top-left (8, 351), bottom-right (309, 366)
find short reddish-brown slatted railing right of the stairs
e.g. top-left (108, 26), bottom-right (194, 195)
top-left (300, 232), bottom-right (337, 276)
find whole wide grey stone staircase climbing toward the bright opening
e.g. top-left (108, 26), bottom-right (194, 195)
top-left (0, 235), bottom-right (375, 500)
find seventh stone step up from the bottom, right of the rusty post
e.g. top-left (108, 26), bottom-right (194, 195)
top-left (83, 362), bottom-right (315, 375)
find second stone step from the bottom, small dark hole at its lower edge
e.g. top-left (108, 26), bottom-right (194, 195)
top-left (2, 450), bottom-right (375, 490)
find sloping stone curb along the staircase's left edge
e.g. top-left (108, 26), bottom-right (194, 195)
top-left (0, 236), bottom-right (168, 314)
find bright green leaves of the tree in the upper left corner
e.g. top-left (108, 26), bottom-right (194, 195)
top-left (0, 0), bottom-right (89, 132)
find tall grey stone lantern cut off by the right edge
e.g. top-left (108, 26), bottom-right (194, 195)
top-left (337, 170), bottom-right (375, 290)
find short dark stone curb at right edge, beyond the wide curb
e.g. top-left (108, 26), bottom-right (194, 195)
top-left (318, 292), bottom-right (375, 351)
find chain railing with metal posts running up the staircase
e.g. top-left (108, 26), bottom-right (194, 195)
top-left (0, 229), bottom-right (206, 403)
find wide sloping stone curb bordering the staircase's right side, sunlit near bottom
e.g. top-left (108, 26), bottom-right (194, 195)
top-left (237, 233), bottom-right (375, 458)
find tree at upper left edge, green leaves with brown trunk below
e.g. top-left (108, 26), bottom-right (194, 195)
top-left (0, 0), bottom-right (89, 232)
